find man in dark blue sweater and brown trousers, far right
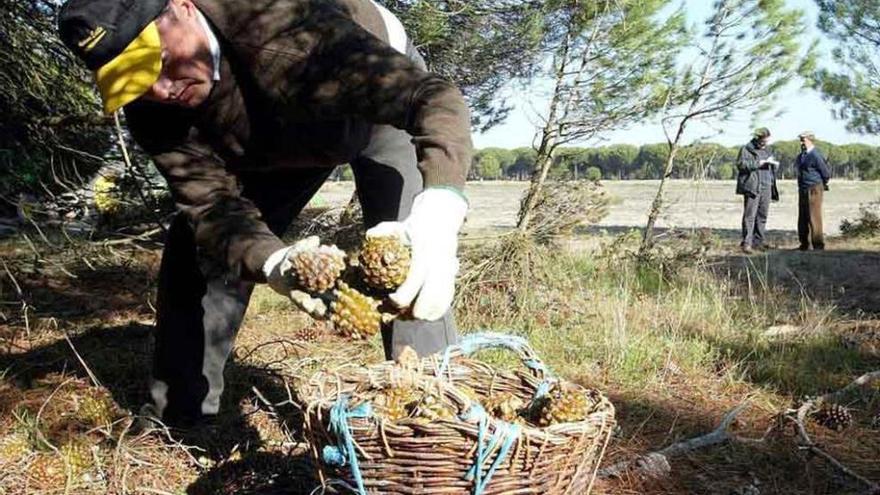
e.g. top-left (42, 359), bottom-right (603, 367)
top-left (796, 131), bottom-right (831, 251)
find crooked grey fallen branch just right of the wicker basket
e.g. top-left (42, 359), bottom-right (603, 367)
top-left (598, 403), bottom-right (748, 478)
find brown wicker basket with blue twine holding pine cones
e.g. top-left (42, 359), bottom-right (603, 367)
top-left (299, 333), bottom-right (615, 495)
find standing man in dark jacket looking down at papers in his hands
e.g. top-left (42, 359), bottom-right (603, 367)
top-left (736, 127), bottom-right (779, 254)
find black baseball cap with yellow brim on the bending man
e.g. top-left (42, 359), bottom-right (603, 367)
top-left (58, 0), bottom-right (168, 114)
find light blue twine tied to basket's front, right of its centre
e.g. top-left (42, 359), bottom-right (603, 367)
top-left (462, 404), bottom-right (521, 495)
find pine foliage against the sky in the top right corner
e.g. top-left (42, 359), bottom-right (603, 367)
top-left (804, 0), bottom-right (880, 134)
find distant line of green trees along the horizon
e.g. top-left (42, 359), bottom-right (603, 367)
top-left (470, 141), bottom-right (880, 180)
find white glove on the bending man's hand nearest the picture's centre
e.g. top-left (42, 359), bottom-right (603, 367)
top-left (367, 188), bottom-right (468, 320)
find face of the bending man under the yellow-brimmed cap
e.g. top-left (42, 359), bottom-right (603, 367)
top-left (141, 0), bottom-right (214, 108)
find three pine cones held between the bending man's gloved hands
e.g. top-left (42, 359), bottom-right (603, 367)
top-left (290, 237), bottom-right (412, 339)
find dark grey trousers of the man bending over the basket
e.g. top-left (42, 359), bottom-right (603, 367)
top-left (150, 126), bottom-right (457, 424)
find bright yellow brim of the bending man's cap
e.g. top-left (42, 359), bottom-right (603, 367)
top-left (95, 22), bottom-right (162, 115)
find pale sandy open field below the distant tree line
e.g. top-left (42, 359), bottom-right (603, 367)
top-left (317, 180), bottom-right (880, 235)
